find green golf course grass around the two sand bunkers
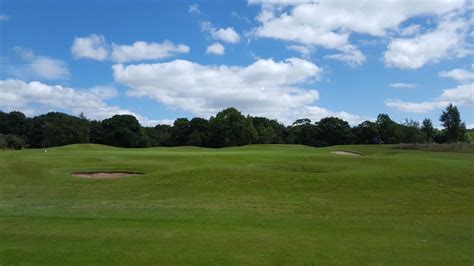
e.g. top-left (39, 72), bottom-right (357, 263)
top-left (0, 145), bottom-right (474, 265)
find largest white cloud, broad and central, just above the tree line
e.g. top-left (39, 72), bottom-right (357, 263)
top-left (113, 58), bottom-right (362, 123)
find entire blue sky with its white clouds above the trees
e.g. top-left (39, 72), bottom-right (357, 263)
top-left (0, 0), bottom-right (474, 128)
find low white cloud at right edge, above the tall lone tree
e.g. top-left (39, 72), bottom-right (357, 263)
top-left (385, 83), bottom-right (474, 113)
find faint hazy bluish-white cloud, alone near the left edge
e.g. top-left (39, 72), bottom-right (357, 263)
top-left (7, 46), bottom-right (70, 80)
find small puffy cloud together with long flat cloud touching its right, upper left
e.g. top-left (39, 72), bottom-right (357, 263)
top-left (71, 34), bottom-right (190, 63)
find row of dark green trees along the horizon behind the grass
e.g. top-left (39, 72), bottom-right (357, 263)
top-left (0, 104), bottom-right (468, 149)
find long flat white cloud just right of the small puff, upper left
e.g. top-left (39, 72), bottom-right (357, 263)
top-left (111, 41), bottom-right (190, 63)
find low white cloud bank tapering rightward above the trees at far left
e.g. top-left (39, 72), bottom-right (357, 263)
top-left (0, 79), bottom-right (154, 125)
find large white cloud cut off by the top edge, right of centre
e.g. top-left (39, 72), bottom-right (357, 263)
top-left (249, 0), bottom-right (464, 65)
